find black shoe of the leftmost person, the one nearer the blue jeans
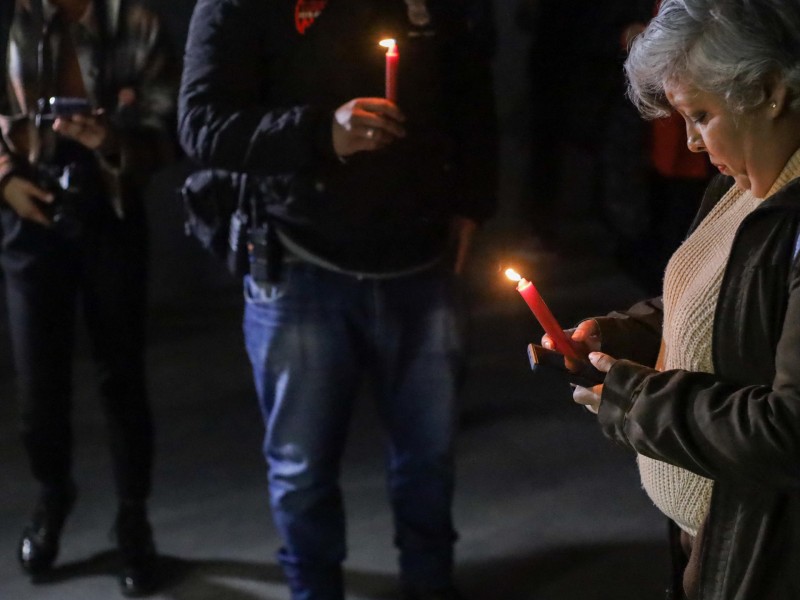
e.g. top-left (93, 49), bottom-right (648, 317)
top-left (114, 506), bottom-right (158, 598)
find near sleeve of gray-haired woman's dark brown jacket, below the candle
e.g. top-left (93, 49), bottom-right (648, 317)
top-left (599, 251), bottom-right (800, 489)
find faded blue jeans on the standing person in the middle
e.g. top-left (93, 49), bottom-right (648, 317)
top-left (244, 264), bottom-right (464, 600)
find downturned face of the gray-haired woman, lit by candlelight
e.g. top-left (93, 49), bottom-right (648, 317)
top-left (665, 83), bottom-right (774, 198)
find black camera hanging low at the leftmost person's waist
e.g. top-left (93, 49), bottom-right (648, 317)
top-left (35, 164), bottom-right (84, 239)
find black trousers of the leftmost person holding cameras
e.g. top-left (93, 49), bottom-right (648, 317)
top-left (0, 200), bottom-right (153, 501)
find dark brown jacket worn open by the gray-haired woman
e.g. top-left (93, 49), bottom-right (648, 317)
top-left (598, 172), bottom-right (800, 600)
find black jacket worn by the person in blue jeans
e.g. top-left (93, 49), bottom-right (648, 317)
top-left (179, 0), bottom-right (496, 273)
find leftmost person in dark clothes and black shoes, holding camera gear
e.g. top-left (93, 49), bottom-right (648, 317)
top-left (0, 0), bottom-right (178, 595)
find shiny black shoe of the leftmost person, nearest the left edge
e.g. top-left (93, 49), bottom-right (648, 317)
top-left (17, 486), bottom-right (77, 578)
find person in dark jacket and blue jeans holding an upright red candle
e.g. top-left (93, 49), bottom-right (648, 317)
top-left (179, 0), bottom-right (495, 600)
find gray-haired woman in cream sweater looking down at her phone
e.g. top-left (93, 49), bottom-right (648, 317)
top-left (543, 0), bottom-right (800, 600)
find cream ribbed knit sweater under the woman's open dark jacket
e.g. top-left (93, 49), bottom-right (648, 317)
top-left (637, 151), bottom-right (800, 536)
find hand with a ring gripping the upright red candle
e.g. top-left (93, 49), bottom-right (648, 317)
top-left (333, 98), bottom-right (406, 158)
